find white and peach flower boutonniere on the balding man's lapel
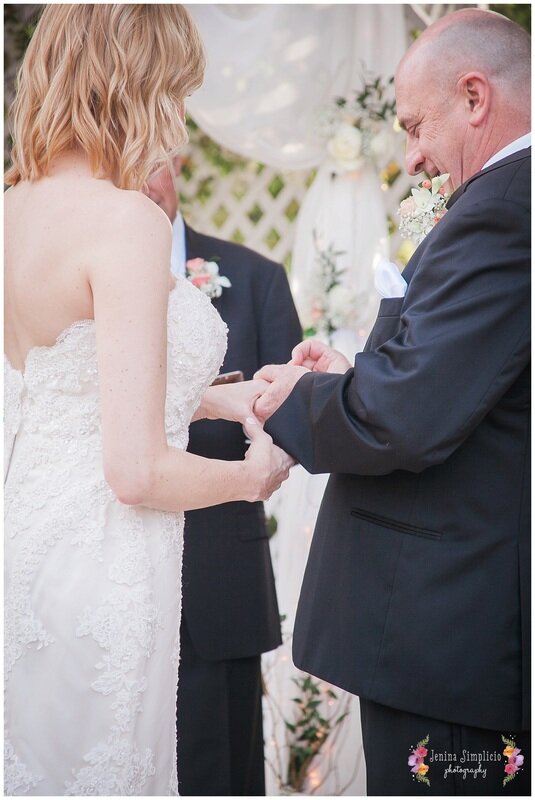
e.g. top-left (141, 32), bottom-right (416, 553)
top-left (398, 173), bottom-right (450, 245)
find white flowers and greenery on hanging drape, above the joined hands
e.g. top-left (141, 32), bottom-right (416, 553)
top-left (305, 234), bottom-right (358, 342)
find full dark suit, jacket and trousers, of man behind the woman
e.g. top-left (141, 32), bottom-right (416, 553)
top-left (178, 226), bottom-right (301, 795)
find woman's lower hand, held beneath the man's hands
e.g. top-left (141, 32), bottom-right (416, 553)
top-left (244, 416), bottom-right (295, 501)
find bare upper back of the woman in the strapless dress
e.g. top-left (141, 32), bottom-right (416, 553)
top-left (4, 154), bottom-right (152, 371)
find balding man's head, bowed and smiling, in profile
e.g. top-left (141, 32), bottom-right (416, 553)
top-left (396, 9), bottom-right (531, 187)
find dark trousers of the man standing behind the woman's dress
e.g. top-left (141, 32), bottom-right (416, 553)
top-left (177, 619), bottom-right (265, 796)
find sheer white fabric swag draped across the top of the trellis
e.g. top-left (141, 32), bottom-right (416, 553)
top-left (186, 4), bottom-right (405, 170)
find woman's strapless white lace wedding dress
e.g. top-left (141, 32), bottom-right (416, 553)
top-left (4, 278), bottom-right (226, 795)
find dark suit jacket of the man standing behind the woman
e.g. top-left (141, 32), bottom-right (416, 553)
top-left (182, 226), bottom-right (301, 660)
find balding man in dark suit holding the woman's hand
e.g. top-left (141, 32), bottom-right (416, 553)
top-left (255, 9), bottom-right (531, 795)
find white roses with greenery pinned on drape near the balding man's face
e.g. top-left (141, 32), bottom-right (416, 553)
top-left (320, 78), bottom-right (402, 177)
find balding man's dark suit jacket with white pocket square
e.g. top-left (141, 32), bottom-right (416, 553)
top-left (267, 150), bottom-right (531, 732)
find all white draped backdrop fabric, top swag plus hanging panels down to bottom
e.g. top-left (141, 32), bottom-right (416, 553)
top-left (188, 4), bottom-right (406, 795)
